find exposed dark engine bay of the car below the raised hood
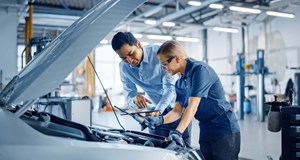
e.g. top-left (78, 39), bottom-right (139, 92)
top-left (10, 109), bottom-right (201, 160)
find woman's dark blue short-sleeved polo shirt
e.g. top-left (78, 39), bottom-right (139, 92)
top-left (175, 58), bottom-right (240, 139)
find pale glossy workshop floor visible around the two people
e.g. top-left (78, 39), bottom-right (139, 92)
top-left (92, 111), bottom-right (281, 160)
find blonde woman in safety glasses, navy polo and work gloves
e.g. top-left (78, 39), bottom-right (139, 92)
top-left (146, 41), bottom-right (240, 160)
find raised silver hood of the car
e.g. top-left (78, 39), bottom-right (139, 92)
top-left (0, 0), bottom-right (146, 106)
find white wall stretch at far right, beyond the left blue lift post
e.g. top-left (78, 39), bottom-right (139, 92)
top-left (248, 6), bottom-right (300, 94)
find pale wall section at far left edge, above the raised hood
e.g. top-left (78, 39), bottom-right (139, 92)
top-left (0, 9), bottom-right (18, 88)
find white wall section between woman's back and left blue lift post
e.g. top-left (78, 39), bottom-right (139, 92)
top-left (207, 27), bottom-right (242, 94)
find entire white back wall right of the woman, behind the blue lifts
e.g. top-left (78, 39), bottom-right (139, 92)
top-left (198, 6), bottom-right (300, 97)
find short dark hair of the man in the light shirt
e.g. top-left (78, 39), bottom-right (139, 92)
top-left (111, 32), bottom-right (137, 51)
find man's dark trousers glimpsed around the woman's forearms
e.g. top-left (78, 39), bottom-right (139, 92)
top-left (149, 108), bottom-right (192, 145)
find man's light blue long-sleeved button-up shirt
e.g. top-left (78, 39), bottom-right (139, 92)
top-left (119, 45), bottom-right (178, 113)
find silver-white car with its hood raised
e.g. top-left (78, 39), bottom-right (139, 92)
top-left (0, 0), bottom-right (200, 160)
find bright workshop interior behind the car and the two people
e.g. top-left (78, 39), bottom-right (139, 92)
top-left (0, 0), bottom-right (300, 160)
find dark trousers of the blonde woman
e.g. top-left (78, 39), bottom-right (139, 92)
top-left (199, 133), bottom-right (241, 160)
